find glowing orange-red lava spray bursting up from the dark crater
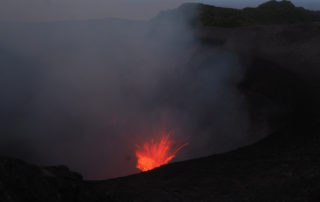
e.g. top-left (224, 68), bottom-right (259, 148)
top-left (136, 133), bottom-right (188, 171)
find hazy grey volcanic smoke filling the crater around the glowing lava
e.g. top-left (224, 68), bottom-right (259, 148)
top-left (0, 6), bottom-right (255, 179)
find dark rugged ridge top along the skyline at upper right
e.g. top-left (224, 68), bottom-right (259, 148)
top-left (154, 0), bottom-right (320, 27)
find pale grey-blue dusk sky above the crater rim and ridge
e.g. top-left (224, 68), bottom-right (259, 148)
top-left (0, 0), bottom-right (320, 21)
